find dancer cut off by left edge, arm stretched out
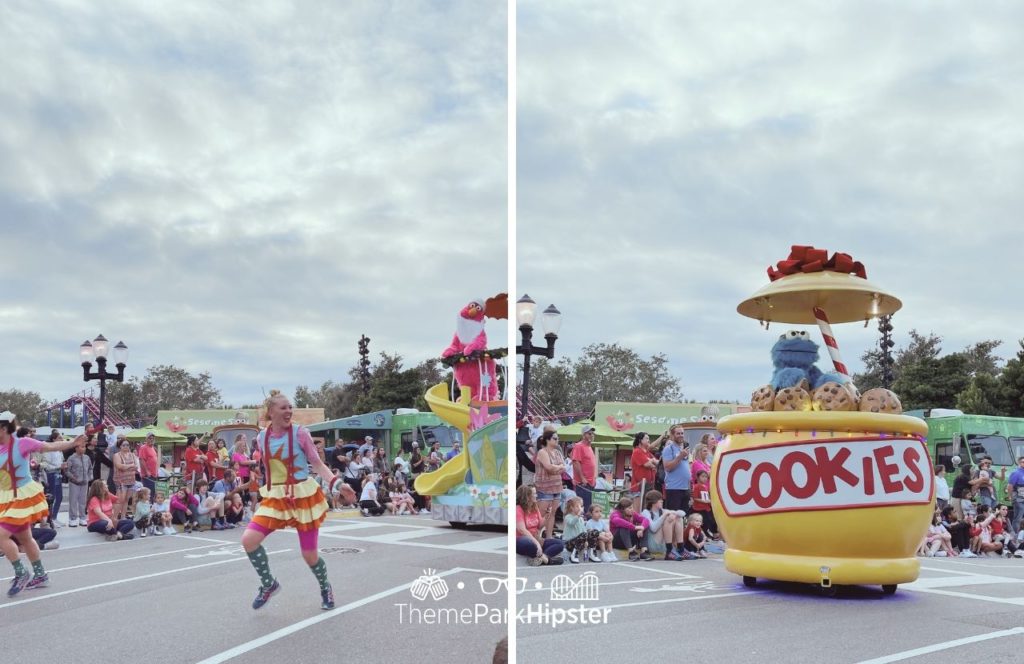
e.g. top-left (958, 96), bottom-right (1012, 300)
top-left (0, 411), bottom-right (85, 597)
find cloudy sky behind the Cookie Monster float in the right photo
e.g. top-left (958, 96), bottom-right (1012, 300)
top-left (516, 0), bottom-right (1024, 401)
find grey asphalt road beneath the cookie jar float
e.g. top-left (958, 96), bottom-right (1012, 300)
top-left (516, 555), bottom-right (1024, 664)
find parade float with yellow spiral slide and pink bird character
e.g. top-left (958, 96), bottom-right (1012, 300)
top-left (415, 293), bottom-right (509, 527)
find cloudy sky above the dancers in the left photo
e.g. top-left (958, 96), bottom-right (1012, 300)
top-left (0, 0), bottom-right (507, 406)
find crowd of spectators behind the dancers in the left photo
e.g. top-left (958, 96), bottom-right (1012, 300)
top-left (24, 431), bottom-right (444, 548)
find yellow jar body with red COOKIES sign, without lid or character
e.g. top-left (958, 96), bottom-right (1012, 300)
top-left (711, 411), bottom-right (935, 592)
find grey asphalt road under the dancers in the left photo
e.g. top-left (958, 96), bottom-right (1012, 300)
top-left (0, 514), bottom-right (507, 664)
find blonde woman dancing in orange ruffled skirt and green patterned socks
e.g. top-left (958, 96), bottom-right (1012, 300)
top-left (242, 389), bottom-right (334, 611)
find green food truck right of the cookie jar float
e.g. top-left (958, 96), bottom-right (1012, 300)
top-left (904, 408), bottom-right (1024, 502)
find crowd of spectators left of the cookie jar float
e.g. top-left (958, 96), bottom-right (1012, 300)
top-left (516, 418), bottom-right (722, 566)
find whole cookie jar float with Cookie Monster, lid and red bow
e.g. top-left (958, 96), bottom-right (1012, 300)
top-left (712, 246), bottom-right (935, 594)
